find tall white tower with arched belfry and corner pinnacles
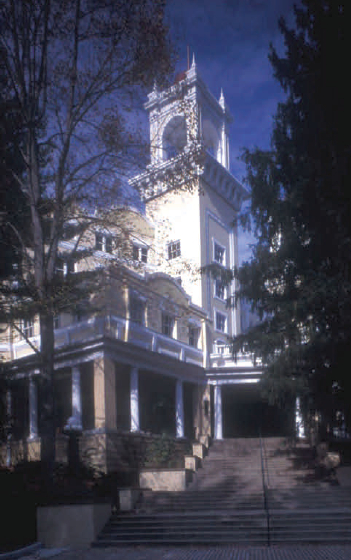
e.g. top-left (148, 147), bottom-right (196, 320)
top-left (133, 58), bottom-right (248, 354)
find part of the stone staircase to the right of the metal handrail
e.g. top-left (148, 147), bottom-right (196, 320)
top-left (263, 440), bottom-right (351, 544)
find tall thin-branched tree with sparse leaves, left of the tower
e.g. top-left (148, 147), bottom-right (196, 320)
top-left (0, 0), bottom-right (171, 484)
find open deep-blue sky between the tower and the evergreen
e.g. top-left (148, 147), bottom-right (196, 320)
top-left (167, 0), bottom-right (296, 260)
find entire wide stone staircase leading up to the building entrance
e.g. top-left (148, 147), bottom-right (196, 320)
top-left (94, 438), bottom-right (351, 546)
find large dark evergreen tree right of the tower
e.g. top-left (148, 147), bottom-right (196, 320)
top-left (234, 0), bottom-right (351, 434)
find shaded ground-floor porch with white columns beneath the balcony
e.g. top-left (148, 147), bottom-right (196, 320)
top-left (0, 324), bottom-right (209, 468)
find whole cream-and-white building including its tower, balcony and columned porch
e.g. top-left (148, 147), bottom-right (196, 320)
top-left (0, 61), bottom-right (292, 471)
